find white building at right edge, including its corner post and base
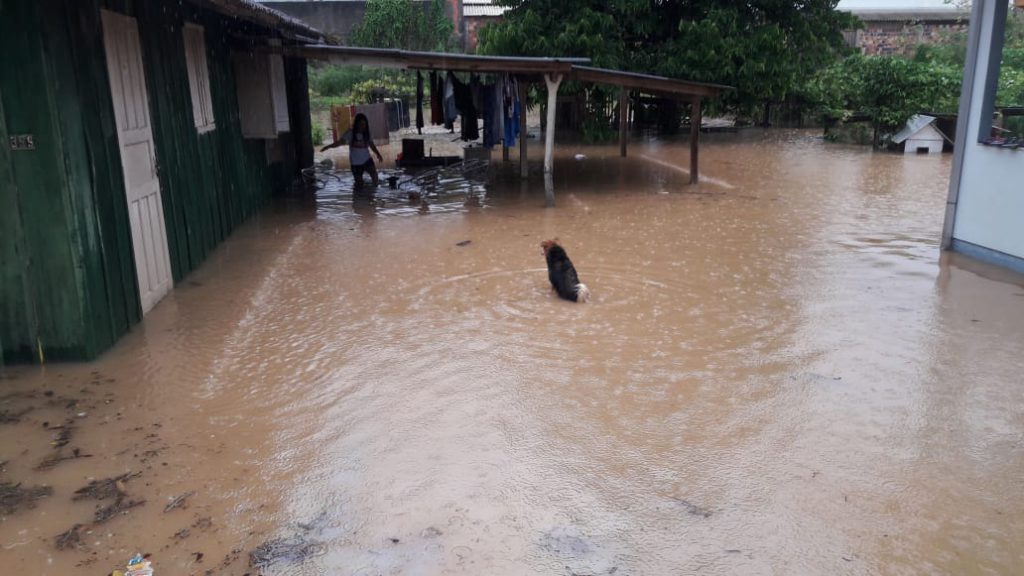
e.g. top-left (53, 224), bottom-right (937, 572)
top-left (942, 0), bottom-right (1024, 272)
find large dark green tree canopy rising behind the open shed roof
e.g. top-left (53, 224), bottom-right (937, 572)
top-left (478, 0), bottom-right (856, 111)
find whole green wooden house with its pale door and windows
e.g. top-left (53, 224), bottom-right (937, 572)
top-left (0, 0), bottom-right (323, 363)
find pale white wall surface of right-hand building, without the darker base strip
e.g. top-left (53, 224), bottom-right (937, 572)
top-left (952, 0), bottom-right (1024, 258)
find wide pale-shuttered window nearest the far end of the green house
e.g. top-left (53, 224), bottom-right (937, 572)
top-left (231, 52), bottom-right (291, 138)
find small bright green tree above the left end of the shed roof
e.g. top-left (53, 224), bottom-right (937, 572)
top-left (352, 0), bottom-right (455, 51)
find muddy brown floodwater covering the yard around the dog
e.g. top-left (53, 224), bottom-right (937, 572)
top-left (0, 131), bottom-right (1024, 576)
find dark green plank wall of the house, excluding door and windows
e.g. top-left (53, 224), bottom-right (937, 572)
top-left (0, 0), bottom-right (308, 362)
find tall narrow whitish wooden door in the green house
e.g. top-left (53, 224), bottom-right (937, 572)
top-left (102, 10), bottom-right (172, 314)
